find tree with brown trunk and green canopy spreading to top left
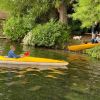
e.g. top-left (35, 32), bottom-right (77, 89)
top-left (0, 0), bottom-right (73, 23)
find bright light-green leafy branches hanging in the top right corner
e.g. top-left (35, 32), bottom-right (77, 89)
top-left (73, 0), bottom-right (100, 27)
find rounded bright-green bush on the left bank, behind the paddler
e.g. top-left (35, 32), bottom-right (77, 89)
top-left (4, 17), bottom-right (33, 41)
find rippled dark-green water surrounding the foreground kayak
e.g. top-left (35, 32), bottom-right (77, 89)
top-left (0, 41), bottom-right (100, 100)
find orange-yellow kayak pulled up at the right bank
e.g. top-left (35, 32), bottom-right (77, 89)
top-left (68, 43), bottom-right (100, 51)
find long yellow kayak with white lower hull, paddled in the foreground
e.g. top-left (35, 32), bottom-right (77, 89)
top-left (0, 56), bottom-right (68, 69)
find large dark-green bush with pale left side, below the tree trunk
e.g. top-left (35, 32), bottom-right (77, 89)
top-left (23, 21), bottom-right (69, 48)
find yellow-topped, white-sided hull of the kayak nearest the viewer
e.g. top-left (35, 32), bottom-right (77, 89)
top-left (0, 56), bottom-right (68, 69)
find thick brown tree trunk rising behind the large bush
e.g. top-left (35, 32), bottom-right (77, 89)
top-left (58, 2), bottom-right (67, 24)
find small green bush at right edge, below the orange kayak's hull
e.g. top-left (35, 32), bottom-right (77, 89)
top-left (84, 46), bottom-right (100, 59)
